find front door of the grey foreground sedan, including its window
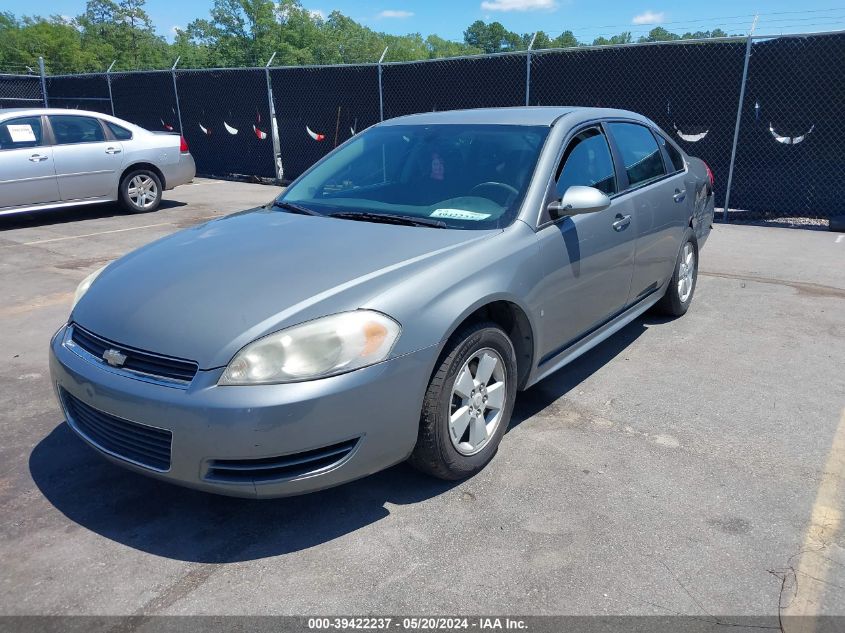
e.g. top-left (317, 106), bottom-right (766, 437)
top-left (537, 126), bottom-right (635, 364)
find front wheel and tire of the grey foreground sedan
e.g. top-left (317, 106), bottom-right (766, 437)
top-left (409, 323), bottom-right (517, 480)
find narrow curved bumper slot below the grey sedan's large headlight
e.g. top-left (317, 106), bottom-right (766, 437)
top-left (205, 439), bottom-right (358, 482)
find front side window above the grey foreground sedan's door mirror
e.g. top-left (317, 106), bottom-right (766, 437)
top-left (556, 128), bottom-right (616, 198)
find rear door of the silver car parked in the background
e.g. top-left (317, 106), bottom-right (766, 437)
top-left (48, 114), bottom-right (123, 201)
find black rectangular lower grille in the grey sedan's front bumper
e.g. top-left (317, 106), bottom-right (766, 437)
top-left (61, 389), bottom-right (172, 471)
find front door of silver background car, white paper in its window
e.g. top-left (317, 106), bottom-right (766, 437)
top-left (0, 116), bottom-right (59, 210)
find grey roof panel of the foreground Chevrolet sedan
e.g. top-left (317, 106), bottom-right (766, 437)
top-left (381, 106), bottom-right (653, 126)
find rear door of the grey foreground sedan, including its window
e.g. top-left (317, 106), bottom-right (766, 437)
top-left (607, 121), bottom-right (688, 304)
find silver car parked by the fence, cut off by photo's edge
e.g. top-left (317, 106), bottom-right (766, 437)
top-left (0, 108), bottom-right (196, 215)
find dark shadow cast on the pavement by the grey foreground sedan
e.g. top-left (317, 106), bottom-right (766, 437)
top-left (29, 319), bottom-right (657, 563)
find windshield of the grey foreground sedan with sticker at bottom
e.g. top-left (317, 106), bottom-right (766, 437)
top-left (277, 124), bottom-right (549, 229)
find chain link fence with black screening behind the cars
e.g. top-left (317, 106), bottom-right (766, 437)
top-left (0, 32), bottom-right (845, 221)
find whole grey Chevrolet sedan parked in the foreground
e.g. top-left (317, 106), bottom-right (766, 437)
top-left (51, 108), bottom-right (713, 496)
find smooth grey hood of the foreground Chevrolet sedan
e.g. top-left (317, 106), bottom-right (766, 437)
top-left (71, 208), bottom-right (498, 369)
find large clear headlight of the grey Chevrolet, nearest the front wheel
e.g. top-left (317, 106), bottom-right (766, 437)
top-left (218, 310), bottom-right (401, 385)
